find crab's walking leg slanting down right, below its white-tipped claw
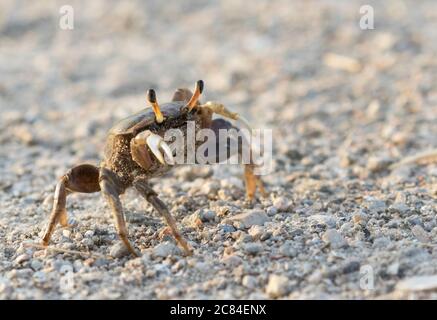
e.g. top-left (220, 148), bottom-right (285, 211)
top-left (134, 178), bottom-right (191, 255)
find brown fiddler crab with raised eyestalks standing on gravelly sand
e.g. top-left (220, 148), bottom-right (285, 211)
top-left (41, 80), bottom-right (265, 256)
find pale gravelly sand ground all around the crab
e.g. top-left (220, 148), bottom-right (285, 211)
top-left (0, 0), bottom-right (437, 299)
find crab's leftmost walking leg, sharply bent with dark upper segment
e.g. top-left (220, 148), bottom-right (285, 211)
top-left (42, 164), bottom-right (100, 246)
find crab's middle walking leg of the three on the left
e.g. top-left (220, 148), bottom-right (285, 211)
top-left (100, 168), bottom-right (139, 256)
